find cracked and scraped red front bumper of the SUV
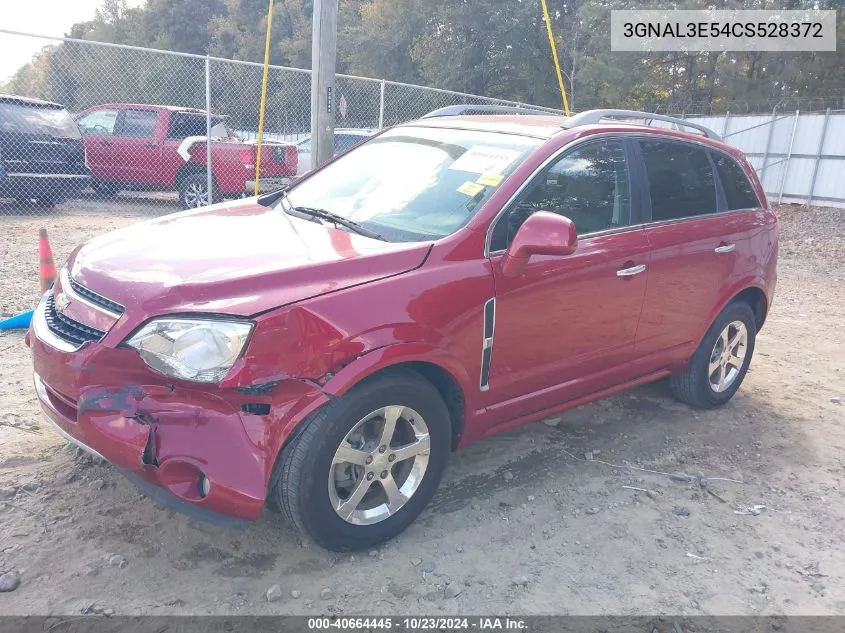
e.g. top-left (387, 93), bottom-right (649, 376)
top-left (28, 290), bottom-right (322, 525)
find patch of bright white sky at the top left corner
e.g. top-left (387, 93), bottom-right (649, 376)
top-left (0, 0), bottom-right (143, 81)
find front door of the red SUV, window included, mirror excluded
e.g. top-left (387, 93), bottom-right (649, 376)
top-left (481, 138), bottom-right (648, 426)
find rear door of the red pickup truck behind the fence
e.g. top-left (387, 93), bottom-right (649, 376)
top-left (114, 109), bottom-right (162, 185)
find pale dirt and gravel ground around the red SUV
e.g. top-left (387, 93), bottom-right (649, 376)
top-left (0, 200), bottom-right (845, 615)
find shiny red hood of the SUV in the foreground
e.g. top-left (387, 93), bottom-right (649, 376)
top-left (68, 199), bottom-right (431, 316)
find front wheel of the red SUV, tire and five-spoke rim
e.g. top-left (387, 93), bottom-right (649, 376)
top-left (268, 370), bottom-right (452, 551)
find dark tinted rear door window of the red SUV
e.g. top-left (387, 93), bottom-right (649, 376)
top-left (640, 141), bottom-right (717, 222)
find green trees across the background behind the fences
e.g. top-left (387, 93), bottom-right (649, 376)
top-left (3, 0), bottom-right (845, 118)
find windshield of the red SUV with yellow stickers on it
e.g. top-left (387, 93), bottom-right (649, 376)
top-left (282, 126), bottom-right (542, 242)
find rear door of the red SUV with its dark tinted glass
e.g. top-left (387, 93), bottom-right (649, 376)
top-left (637, 138), bottom-right (766, 365)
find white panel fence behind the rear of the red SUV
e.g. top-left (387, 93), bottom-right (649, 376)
top-left (687, 110), bottom-right (845, 208)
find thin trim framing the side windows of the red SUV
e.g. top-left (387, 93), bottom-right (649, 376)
top-left (484, 131), bottom-right (765, 258)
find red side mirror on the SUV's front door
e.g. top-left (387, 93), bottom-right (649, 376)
top-left (502, 211), bottom-right (578, 277)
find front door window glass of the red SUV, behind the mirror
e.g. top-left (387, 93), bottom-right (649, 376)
top-left (490, 140), bottom-right (631, 252)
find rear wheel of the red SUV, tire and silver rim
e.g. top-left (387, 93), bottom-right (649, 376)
top-left (669, 302), bottom-right (757, 409)
